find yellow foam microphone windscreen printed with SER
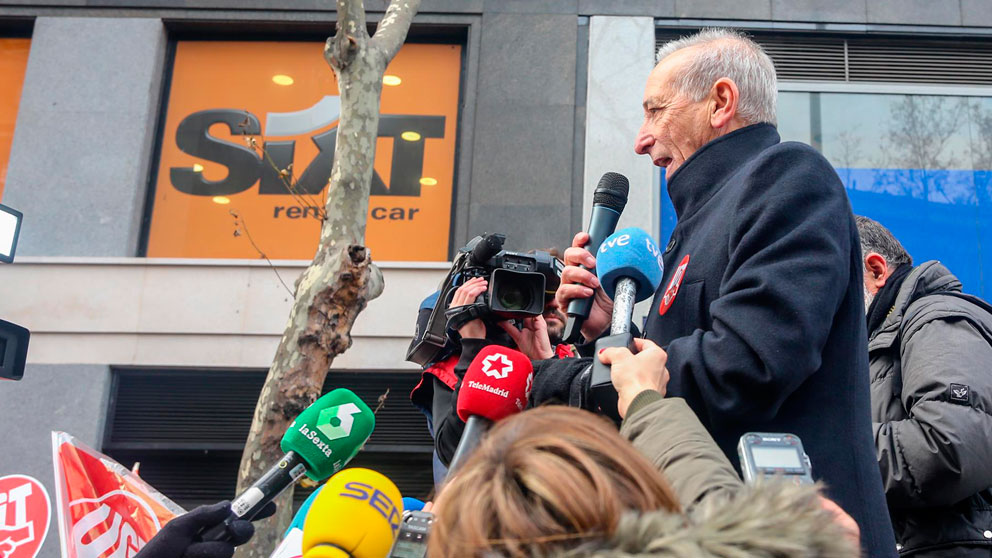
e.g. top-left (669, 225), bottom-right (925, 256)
top-left (303, 468), bottom-right (403, 558)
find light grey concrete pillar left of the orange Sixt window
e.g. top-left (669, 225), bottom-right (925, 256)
top-left (4, 17), bottom-right (166, 256)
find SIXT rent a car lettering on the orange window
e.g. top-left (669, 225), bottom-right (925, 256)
top-left (169, 95), bottom-right (445, 220)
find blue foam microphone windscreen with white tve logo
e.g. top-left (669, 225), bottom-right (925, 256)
top-left (596, 227), bottom-right (664, 302)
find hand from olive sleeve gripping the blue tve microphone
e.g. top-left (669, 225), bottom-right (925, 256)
top-left (599, 339), bottom-right (669, 418)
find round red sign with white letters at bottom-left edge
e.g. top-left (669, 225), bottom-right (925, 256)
top-left (0, 475), bottom-right (52, 558)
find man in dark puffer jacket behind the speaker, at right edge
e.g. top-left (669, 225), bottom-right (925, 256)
top-left (857, 216), bottom-right (992, 558)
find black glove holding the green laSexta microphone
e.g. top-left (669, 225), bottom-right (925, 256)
top-left (134, 502), bottom-right (276, 558)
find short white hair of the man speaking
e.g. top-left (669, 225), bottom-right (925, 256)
top-left (657, 28), bottom-right (778, 125)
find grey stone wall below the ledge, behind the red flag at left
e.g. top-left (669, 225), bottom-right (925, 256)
top-left (0, 365), bottom-right (110, 558)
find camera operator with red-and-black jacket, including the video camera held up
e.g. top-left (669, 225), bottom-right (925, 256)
top-left (407, 238), bottom-right (575, 483)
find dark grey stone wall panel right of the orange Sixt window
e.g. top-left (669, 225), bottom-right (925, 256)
top-left (464, 13), bottom-right (581, 253)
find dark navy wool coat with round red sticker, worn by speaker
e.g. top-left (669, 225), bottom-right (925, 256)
top-left (645, 124), bottom-right (896, 557)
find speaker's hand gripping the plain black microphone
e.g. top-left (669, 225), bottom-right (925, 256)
top-left (555, 232), bottom-right (613, 341)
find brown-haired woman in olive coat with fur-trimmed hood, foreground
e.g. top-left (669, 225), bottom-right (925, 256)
top-left (428, 356), bottom-right (859, 558)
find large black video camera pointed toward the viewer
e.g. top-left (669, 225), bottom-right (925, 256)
top-left (406, 233), bottom-right (564, 366)
